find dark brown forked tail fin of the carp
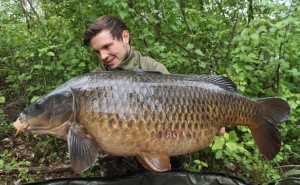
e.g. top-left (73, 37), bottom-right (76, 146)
top-left (250, 98), bottom-right (290, 160)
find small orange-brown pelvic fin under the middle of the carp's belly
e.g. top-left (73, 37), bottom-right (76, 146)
top-left (136, 152), bottom-right (171, 172)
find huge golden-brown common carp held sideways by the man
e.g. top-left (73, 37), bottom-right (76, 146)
top-left (14, 71), bottom-right (290, 173)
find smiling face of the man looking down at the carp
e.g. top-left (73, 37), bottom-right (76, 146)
top-left (90, 30), bottom-right (130, 69)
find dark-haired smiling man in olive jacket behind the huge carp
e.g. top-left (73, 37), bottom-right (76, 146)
top-left (84, 16), bottom-right (169, 74)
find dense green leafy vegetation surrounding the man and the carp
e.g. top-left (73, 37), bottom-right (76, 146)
top-left (0, 0), bottom-right (300, 183)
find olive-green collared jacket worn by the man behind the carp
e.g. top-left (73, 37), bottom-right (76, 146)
top-left (94, 49), bottom-right (169, 74)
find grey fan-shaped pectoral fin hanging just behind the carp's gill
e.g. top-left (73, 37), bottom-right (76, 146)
top-left (68, 127), bottom-right (99, 174)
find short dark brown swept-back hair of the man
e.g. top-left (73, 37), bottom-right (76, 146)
top-left (83, 15), bottom-right (128, 46)
